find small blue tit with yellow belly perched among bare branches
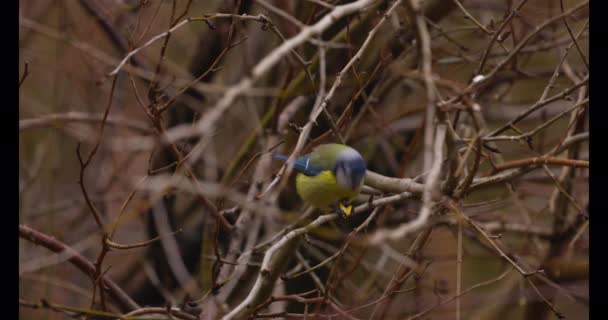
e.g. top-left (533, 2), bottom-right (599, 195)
top-left (273, 143), bottom-right (366, 218)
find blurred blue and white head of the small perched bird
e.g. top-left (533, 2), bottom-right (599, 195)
top-left (333, 148), bottom-right (366, 190)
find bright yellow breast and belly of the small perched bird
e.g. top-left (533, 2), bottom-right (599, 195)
top-left (296, 171), bottom-right (359, 209)
